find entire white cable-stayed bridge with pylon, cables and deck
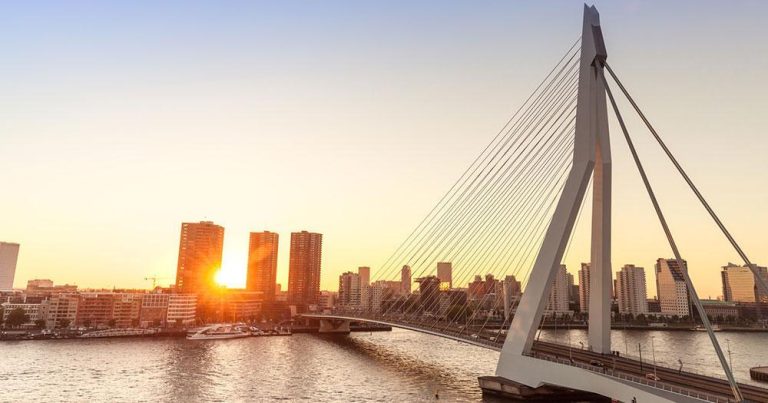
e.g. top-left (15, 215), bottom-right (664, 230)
top-left (303, 6), bottom-right (768, 402)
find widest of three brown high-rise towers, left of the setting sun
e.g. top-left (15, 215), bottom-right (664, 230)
top-left (176, 221), bottom-right (224, 294)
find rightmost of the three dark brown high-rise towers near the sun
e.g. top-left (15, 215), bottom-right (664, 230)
top-left (288, 231), bottom-right (323, 309)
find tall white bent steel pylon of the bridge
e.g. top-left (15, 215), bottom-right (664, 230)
top-left (496, 5), bottom-right (680, 402)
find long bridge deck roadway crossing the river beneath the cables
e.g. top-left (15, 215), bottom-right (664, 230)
top-left (303, 314), bottom-right (768, 402)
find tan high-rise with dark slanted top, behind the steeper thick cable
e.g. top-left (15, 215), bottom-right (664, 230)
top-left (656, 258), bottom-right (690, 317)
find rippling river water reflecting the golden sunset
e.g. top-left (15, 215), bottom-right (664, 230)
top-left (0, 329), bottom-right (768, 402)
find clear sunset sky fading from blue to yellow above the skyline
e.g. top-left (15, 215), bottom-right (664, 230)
top-left (0, 1), bottom-right (768, 297)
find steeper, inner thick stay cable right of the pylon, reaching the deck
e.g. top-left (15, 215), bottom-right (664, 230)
top-left (599, 69), bottom-right (744, 402)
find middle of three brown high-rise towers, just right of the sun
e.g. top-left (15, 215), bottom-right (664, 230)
top-left (245, 231), bottom-right (279, 302)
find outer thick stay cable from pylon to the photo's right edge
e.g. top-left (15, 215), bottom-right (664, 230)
top-left (604, 63), bottom-right (768, 295)
